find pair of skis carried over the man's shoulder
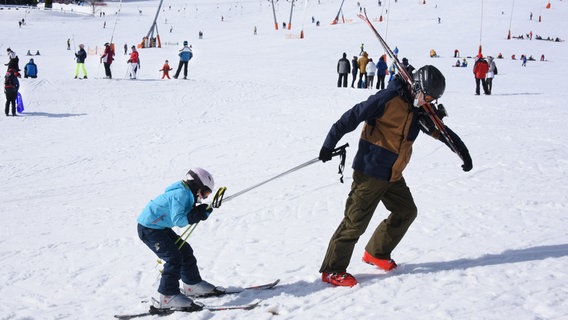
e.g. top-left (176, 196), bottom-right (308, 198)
top-left (358, 9), bottom-right (463, 160)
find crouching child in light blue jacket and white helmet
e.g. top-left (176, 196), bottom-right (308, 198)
top-left (137, 168), bottom-right (225, 309)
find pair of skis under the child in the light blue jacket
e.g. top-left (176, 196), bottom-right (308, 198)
top-left (114, 279), bottom-right (280, 320)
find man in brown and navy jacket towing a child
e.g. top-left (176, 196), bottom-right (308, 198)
top-left (319, 65), bottom-right (472, 286)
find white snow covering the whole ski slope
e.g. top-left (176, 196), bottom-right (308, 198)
top-left (0, 0), bottom-right (568, 320)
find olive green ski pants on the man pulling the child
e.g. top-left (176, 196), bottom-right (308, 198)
top-left (320, 171), bottom-right (417, 273)
